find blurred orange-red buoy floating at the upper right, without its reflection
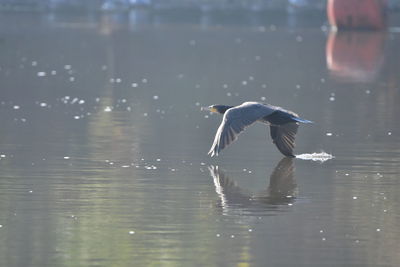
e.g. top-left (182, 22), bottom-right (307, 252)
top-left (327, 0), bottom-right (387, 30)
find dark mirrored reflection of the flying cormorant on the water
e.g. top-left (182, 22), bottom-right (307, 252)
top-left (209, 157), bottom-right (297, 216)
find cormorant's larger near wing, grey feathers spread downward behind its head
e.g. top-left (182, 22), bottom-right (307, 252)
top-left (208, 102), bottom-right (275, 157)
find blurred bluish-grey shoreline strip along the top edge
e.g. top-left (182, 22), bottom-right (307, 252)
top-left (0, 0), bottom-right (400, 13)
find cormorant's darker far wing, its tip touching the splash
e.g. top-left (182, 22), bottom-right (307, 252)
top-left (270, 122), bottom-right (299, 157)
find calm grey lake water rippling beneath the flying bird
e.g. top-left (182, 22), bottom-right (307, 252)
top-left (0, 10), bottom-right (400, 266)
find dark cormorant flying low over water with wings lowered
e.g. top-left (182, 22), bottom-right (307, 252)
top-left (202, 102), bottom-right (312, 158)
